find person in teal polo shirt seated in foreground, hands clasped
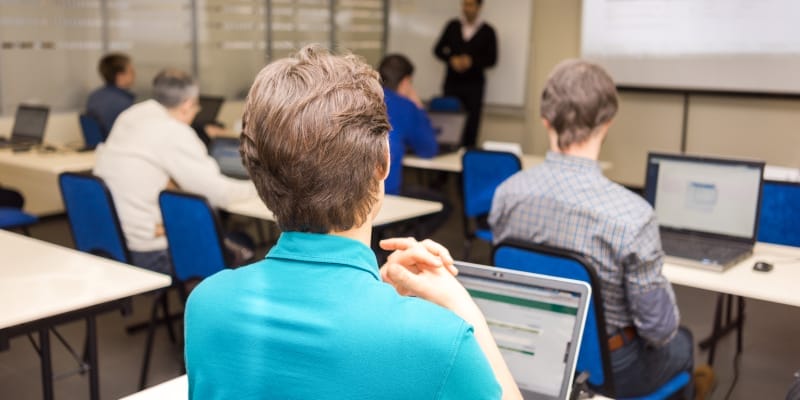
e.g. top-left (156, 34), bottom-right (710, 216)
top-left (185, 46), bottom-right (521, 399)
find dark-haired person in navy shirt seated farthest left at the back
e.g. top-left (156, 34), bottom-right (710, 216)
top-left (86, 53), bottom-right (136, 137)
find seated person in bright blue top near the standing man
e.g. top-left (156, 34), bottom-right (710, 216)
top-left (378, 54), bottom-right (439, 194)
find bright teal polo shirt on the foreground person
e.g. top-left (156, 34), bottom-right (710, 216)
top-left (185, 232), bottom-right (501, 400)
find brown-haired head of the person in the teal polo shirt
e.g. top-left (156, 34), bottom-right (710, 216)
top-left (241, 45), bottom-right (389, 233)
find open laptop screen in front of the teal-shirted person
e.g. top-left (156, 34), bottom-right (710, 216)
top-left (455, 261), bottom-right (592, 400)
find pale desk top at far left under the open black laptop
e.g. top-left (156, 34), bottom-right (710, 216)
top-left (0, 149), bottom-right (94, 175)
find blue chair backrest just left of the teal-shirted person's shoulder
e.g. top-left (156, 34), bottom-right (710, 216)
top-left (158, 191), bottom-right (227, 281)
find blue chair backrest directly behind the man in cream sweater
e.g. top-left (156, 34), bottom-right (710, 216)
top-left (58, 172), bottom-right (130, 263)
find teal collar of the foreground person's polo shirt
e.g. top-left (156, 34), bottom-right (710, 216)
top-left (266, 232), bottom-right (381, 280)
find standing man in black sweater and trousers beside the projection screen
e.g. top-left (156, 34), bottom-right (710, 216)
top-left (433, 0), bottom-right (497, 147)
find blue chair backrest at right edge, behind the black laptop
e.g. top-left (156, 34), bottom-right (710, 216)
top-left (758, 181), bottom-right (800, 246)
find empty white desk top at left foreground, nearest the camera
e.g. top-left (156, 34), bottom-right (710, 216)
top-left (0, 231), bottom-right (172, 329)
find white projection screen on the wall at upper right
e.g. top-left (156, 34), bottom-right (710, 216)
top-left (581, 0), bottom-right (800, 93)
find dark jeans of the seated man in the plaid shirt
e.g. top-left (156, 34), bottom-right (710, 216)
top-left (611, 328), bottom-right (694, 400)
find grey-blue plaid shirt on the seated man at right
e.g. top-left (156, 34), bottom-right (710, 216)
top-left (489, 152), bottom-right (679, 344)
